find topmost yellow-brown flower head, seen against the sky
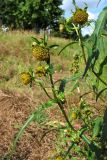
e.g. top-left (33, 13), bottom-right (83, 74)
top-left (72, 8), bottom-right (88, 25)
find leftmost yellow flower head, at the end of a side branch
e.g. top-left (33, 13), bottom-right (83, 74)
top-left (20, 72), bottom-right (32, 85)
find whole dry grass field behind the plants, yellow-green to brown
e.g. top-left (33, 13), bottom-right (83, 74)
top-left (0, 31), bottom-right (104, 160)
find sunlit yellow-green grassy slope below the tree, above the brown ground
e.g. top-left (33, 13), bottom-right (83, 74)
top-left (0, 31), bottom-right (107, 97)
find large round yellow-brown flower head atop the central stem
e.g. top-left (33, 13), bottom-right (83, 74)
top-left (32, 45), bottom-right (50, 62)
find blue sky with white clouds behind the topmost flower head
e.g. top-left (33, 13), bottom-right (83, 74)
top-left (61, 0), bottom-right (107, 35)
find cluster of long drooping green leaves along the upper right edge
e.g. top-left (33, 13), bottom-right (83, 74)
top-left (83, 7), bottom-right (107, 99)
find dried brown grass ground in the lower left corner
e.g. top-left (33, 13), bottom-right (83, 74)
top-left (0, 90), bottom-right (56, 160)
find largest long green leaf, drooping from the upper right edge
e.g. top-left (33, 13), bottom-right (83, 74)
top-left (83, 7), bottom-right (107, 84)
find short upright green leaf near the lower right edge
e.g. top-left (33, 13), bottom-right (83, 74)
top-left (92, 117), bottom-right (103, 138)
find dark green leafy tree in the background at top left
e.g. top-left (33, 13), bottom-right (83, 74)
top-left (0, 0), bottom-right (63, 31)
